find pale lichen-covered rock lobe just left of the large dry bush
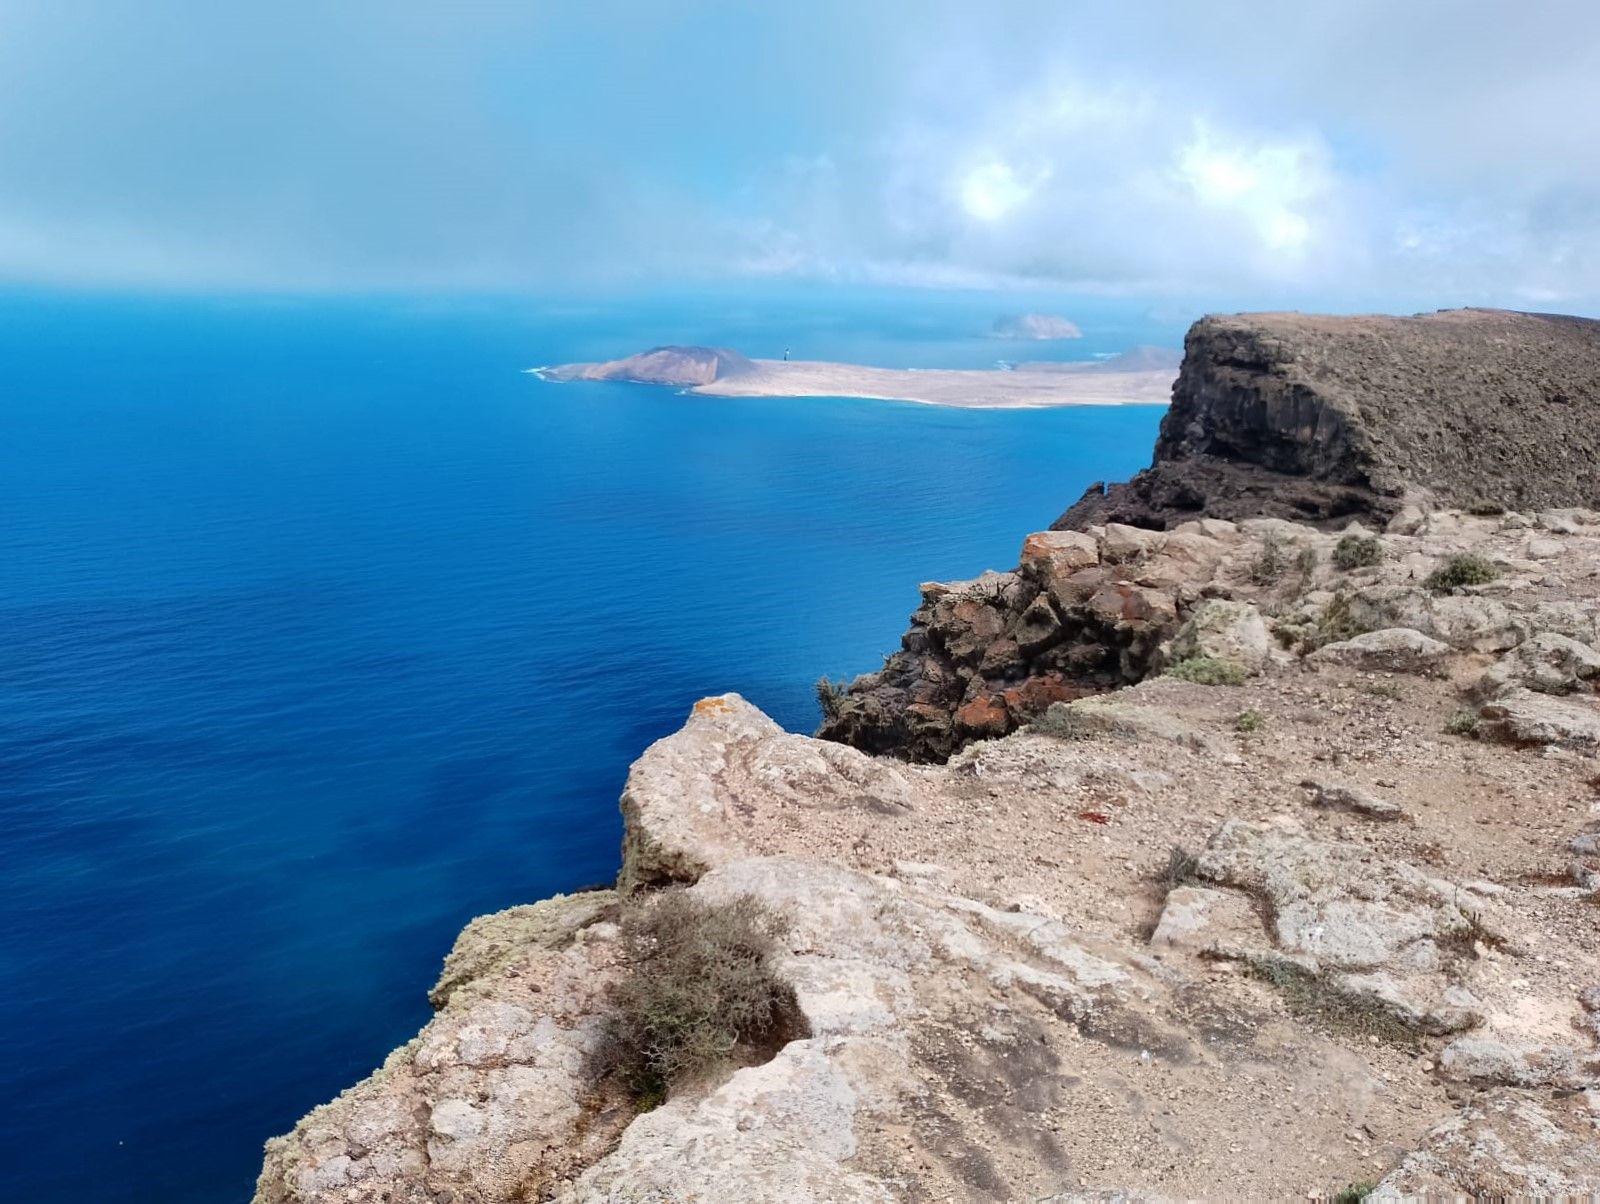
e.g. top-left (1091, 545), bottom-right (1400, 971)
top-left (254, 890), bottom-right (626, 1204)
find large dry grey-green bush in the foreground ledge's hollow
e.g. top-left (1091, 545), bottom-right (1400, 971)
top-left (589, 890), bottom-right (806, 1108)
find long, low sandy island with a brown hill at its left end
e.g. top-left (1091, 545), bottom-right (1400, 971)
top-left (530, 346), bottom-right (1181, 410)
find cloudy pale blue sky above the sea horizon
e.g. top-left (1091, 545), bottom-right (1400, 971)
top-left (0, 0), bottom-right (1600, 312)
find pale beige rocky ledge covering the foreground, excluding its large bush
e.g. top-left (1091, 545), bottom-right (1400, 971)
top-left (256, 509), bottom-right (1600, 1204)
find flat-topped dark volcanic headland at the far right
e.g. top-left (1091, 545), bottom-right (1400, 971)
top-left (1056, 309), bottom-right (1600, 530)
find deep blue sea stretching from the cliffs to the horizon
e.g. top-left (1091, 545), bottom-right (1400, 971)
top-left (0, 286), bottom-right (1178, 1204)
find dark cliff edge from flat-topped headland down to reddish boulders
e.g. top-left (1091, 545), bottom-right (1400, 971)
top-left (821, 311), bottom-right (1600, 759)
